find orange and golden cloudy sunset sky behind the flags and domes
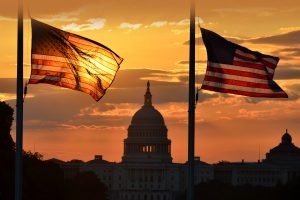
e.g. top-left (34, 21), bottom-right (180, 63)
top-left (0, 0), bottom-right (300, 163)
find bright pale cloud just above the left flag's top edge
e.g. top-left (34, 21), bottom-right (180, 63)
top-left (62, 18), bottom-right (106, 31)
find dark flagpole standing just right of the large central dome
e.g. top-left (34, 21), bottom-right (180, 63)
top-left (187, 0), bottom-right (195, 200)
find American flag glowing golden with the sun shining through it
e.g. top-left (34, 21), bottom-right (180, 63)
top-left (29, 19), bottom-right (123, 101)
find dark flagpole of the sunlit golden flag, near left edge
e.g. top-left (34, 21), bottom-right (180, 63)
top-left (15, 0), bottom-right (23, 200)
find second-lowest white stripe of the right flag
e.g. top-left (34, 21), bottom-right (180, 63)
top-left (206, 71), bottom-right (269, 85)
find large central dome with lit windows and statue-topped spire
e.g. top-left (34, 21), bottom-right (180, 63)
top-left (122, 81), bottom-right (172, 163)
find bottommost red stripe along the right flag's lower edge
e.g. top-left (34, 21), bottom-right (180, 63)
top-left (201, 85), bottom-right (288, 98)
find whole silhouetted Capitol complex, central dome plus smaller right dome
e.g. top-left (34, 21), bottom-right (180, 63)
top-left (52, 82), bottom-right (300, 200)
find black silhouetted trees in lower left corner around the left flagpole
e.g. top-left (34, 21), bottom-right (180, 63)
top-left (0, 101), bottom-right (107, 200)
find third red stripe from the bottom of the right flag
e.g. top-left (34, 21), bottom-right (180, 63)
top-left (207, 66), bottom-right (269, 80)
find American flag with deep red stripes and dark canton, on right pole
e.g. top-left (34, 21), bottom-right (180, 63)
top-left (201, 28), bottom-right (288, 98)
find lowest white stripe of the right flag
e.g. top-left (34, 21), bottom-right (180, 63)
top-left (203, 81), bottom-right (285, 94)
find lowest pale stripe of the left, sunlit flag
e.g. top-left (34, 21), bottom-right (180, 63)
top-left (30, 75), bottom-right (102, 96)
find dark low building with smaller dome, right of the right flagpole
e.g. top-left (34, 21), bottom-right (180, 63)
top-left (214, 131), bottom-right (300, 187)
